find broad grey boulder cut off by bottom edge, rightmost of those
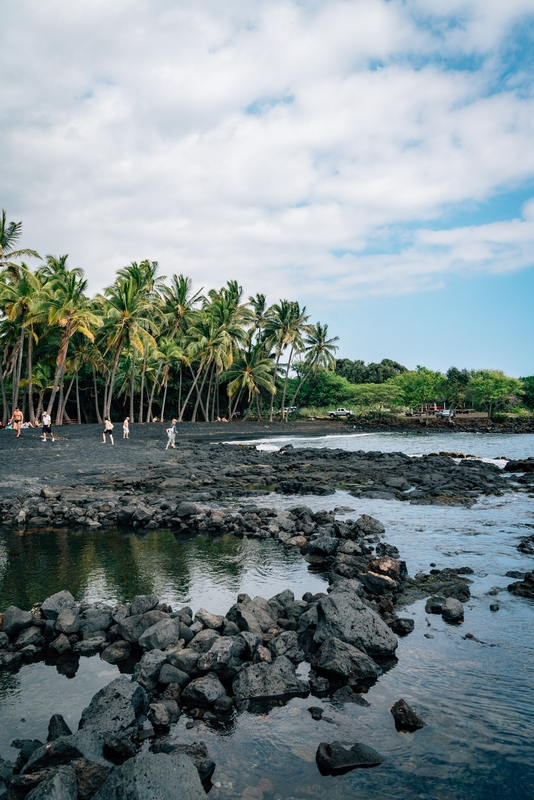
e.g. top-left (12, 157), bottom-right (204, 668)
top-left (94, 753), bottom-right (206, 800)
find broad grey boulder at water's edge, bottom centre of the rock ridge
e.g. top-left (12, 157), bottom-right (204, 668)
top-left (232, 656), bottom-right (309, 699)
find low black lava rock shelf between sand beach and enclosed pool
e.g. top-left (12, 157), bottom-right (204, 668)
top-left (0, 443), bottom-right (534, 535)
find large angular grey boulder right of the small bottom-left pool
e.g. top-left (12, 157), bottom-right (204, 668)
top-left (79, 675), bottom-right (148, 733)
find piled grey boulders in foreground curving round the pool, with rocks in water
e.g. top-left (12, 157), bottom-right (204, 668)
top-left (0, 506), bottom-right (478, 800)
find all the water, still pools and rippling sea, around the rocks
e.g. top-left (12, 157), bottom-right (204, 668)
top-left (0, 434), bottom-right (534, 800)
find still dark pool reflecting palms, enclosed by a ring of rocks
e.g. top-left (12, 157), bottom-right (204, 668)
top-left (0, 530), bottom-right (322, 612)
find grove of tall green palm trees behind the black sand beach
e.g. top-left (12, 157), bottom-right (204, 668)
top-left (0, 211), bottom-right (337, 425)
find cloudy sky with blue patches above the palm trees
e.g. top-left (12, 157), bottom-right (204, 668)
top-left (0, 0), bottom-right (534, 376)
